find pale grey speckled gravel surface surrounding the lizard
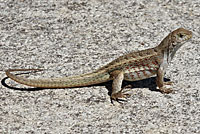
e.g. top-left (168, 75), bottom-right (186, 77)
top-left (0, 0), bottom-right (200, 134)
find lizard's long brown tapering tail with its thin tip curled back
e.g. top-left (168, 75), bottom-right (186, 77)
top-left (6, 69), bottom-right (111, 88)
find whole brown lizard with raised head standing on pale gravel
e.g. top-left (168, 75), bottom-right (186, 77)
top-left (6, 28), bottom-right (192, 100)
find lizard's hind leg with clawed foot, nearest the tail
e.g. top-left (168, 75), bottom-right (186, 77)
top-left (111, 70), bottom-right (130, 100)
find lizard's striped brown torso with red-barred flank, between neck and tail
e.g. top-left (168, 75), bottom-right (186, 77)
top-left (96, 47), bottom-right (162, 81)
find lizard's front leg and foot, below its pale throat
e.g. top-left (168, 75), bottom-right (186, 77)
top-left (156, 67), bottom-right (173, 93)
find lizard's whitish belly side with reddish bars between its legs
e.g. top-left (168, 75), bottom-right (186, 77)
top-left (124, 69), bottom-right (156, 81)
